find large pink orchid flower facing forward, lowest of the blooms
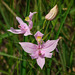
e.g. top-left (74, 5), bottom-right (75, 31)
top-left (19, 31), bottom-right (59, 69)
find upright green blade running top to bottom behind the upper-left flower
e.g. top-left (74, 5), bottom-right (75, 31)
top-left (20, 0), bottom-right (30, 75)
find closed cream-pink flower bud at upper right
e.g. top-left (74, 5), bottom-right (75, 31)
top-left (45, 4), bottom-right (58, 21)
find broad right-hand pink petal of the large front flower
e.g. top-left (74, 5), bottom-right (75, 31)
top-left (42, 39), bottom-right (59, 52)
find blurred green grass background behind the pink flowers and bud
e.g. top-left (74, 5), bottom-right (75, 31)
top-left (0, 0), bottom-right (75, 75)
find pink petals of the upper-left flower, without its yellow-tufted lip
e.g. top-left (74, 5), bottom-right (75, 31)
top-left (8, 17), bottom-right (32, 36)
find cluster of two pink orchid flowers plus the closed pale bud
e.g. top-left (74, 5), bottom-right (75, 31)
top-left (8, 5), bottom-right (59, 69)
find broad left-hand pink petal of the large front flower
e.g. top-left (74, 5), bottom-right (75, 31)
top-left (19, 42), bottom-right (37, 53)
